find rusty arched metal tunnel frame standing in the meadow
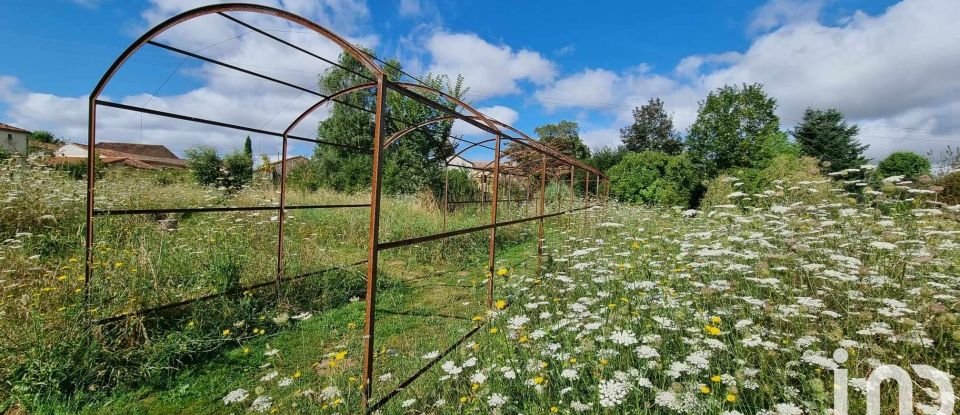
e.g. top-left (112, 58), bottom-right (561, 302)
top-left (83, 3), bottom-right (610, 413)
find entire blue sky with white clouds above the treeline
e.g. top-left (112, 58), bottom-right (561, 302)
top-left (0, 0), bottom-right (960, 164)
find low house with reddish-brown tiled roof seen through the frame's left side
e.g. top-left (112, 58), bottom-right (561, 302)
top-left (48, 143), bottom-right (187, 170)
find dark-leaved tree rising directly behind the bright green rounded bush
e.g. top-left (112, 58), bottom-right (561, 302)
top-left (620, 98), bottom-right (683, 154)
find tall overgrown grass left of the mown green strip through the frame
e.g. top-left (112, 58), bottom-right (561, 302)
top-left (0, 160), bottom-right (576, 409)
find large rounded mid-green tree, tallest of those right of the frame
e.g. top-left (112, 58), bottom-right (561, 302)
top-left (687, 84), bottom-right (791, 177)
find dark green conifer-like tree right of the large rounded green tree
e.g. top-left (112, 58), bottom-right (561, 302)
top-left (791, 108), bottom-right (870, 171)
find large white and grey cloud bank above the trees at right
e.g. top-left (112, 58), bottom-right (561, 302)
top-left (538, 0), bottom-right (960, 161)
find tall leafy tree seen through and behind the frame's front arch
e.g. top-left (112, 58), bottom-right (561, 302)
top-left (307, 54), bottom-right (467, 193)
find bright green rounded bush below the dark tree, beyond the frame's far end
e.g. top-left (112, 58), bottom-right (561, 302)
top-left (608, 151), bottom-right (698, 206)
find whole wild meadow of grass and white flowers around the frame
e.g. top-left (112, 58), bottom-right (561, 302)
top-left (0, 158), bottom-right (960, 414)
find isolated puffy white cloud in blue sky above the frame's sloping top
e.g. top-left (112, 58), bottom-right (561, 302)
top-left (426, 31), bottom-right (556, 98)
